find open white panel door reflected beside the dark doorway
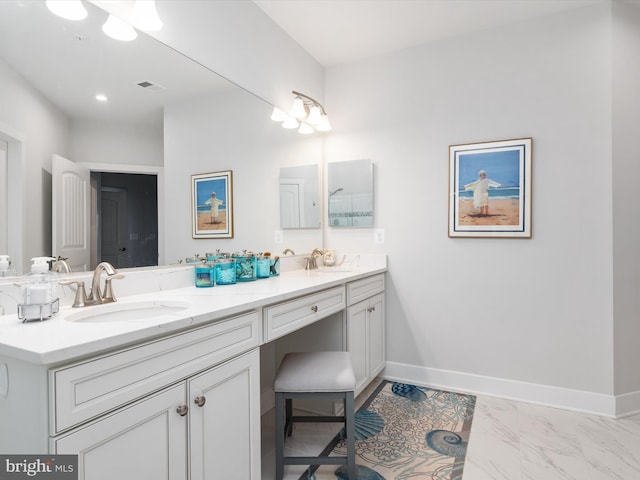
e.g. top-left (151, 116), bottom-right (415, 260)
top-left (51, 154), bottom-right (91, 272)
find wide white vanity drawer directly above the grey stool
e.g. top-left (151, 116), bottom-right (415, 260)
top-left (264, 287), bottom-right (345, 342)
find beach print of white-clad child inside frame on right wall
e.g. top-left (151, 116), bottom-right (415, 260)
top-left (457, 150), bottom-right (521, 225)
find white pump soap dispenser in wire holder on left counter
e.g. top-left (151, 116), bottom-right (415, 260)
top-left (18, 257), bottom-right (59, 322)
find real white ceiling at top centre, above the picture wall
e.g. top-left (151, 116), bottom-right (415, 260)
top-left (254, 0), bottom-right (603, 67)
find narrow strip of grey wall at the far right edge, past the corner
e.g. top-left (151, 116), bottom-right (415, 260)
top-left (613, 3), bottom-right (640, 410)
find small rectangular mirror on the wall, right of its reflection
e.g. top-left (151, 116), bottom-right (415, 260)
top-left (327, 160), bottom-right (373, 227)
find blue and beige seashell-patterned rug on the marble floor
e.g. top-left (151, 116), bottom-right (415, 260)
top-left (300, 381), bottom-right (476, 480)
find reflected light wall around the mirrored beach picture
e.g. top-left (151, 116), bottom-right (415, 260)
top-left (164, 83), bottom-right (322, 263)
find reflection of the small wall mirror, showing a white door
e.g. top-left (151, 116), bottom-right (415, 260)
top-left (280, 165), bottom-right (321, 229)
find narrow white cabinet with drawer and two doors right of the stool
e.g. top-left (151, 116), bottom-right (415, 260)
top-left (347, 274), bottom-right (386, 395)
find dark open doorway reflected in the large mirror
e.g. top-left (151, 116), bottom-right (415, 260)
top-left (91, 172), bottom-right (158, 268)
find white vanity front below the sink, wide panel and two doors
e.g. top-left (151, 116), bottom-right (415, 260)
top-left (49, 311), bottom-right (261, 480)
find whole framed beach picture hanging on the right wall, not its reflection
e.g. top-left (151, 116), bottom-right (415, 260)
top-left (449, 138), bottom-right (532, 238)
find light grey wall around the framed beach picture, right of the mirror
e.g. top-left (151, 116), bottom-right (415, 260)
top-left (325, 4), bottom-right (613, 411)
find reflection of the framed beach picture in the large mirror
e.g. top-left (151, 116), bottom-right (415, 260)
top-left (191, 170), bottom-right (233, 238)
